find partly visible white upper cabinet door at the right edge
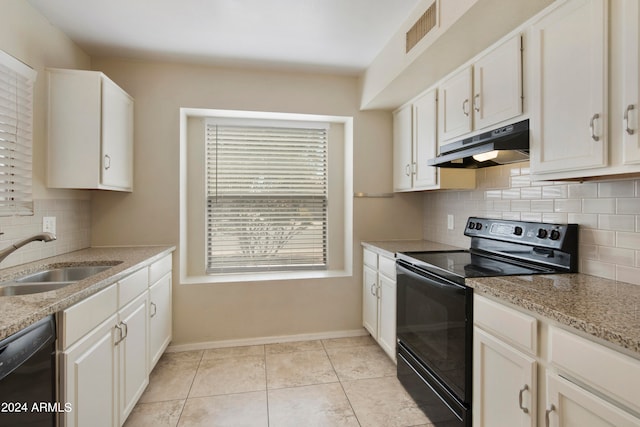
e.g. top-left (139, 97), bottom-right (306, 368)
top-left (621, 0), bottom-right (640, 164)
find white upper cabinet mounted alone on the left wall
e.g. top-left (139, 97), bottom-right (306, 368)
top-left (47, 69), bottom-right (133, 191)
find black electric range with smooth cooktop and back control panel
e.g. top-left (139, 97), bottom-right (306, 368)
top-left (396, 217), bottom-right (578, 427)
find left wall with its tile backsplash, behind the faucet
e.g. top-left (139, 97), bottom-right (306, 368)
top-left (0, 0), bottom-right (91, 268)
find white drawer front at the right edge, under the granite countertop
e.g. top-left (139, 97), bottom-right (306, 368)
top-left (549, 327), bottom-right (640, 411)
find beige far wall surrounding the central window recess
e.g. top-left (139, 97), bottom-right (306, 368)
top-left (92, 58), bottom-right (422, 345)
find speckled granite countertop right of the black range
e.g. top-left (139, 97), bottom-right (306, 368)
top-left (466, 274), bottom-right (640, 358)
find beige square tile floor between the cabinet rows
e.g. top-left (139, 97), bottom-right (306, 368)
top-left (125, 336), bottom-right (431, 427)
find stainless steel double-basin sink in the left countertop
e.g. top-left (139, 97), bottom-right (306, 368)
top-left (0, 262), bottom-right (119, 296)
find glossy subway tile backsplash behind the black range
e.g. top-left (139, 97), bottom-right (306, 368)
top-left (423, 162), bottom-right (640, 285)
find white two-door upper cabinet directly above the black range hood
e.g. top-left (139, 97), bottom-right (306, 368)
top-left (438, 35), bottom-right (522, 145)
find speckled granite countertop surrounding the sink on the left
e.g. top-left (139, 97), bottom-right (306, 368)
top-left (0, 246), bottom-right (175, 339)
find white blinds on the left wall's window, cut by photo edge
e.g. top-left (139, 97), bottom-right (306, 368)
top-left (0, 51), bottom-right (36, 216)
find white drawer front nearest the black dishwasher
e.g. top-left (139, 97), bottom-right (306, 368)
top-left (62, 285), bottom-right (118, 349)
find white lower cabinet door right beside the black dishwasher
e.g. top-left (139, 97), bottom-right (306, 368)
top-left (61, 314), bottom-right (118, 427)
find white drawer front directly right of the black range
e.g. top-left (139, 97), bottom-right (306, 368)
top-left (473, 295), bottom-right (538, 355)
